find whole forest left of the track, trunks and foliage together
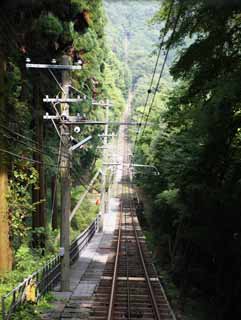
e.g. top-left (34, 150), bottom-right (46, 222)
top-left (0, 0), bottom-right (126, 319)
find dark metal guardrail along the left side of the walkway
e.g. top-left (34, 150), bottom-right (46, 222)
top-left (1, 216), bottom-right (99, 320)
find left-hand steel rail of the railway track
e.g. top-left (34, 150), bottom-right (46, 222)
top-left (107, 188), bottom-right (123, 320)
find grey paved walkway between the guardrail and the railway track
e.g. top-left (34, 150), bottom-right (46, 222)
top-left (42, 194), bottom-right (119, 320)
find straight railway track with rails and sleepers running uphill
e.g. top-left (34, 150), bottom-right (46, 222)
top-left (89, 175), bottom-right (176, 320)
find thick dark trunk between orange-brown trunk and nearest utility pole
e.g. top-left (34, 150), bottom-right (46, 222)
top-left (32, 79), bottom-right (46, 248)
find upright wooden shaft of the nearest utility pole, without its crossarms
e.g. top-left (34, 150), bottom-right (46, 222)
top-left (60, 56), bottom-right (71, 291)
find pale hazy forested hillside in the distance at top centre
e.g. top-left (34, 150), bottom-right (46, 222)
top-left (105, 1), bottom-right (159, 87)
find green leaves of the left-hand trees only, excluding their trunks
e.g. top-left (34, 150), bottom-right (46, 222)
top-left (0, 0), bottom-right (120, 319)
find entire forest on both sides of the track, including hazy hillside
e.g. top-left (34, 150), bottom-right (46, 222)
top-left (0, 0), bottom-right (241, 320)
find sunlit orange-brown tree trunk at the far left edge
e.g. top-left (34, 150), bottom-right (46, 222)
top-left (0, 52), bottom-right (12, 273)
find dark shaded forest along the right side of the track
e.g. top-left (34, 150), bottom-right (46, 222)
top-left (135, 0), bottom-right (241, 319)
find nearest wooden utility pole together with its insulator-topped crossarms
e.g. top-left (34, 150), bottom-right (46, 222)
top-left (26, 55), bottom-right (83, 291)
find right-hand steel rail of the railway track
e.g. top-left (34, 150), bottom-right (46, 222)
top-left (130, 184), bottom-right (161, 320)
